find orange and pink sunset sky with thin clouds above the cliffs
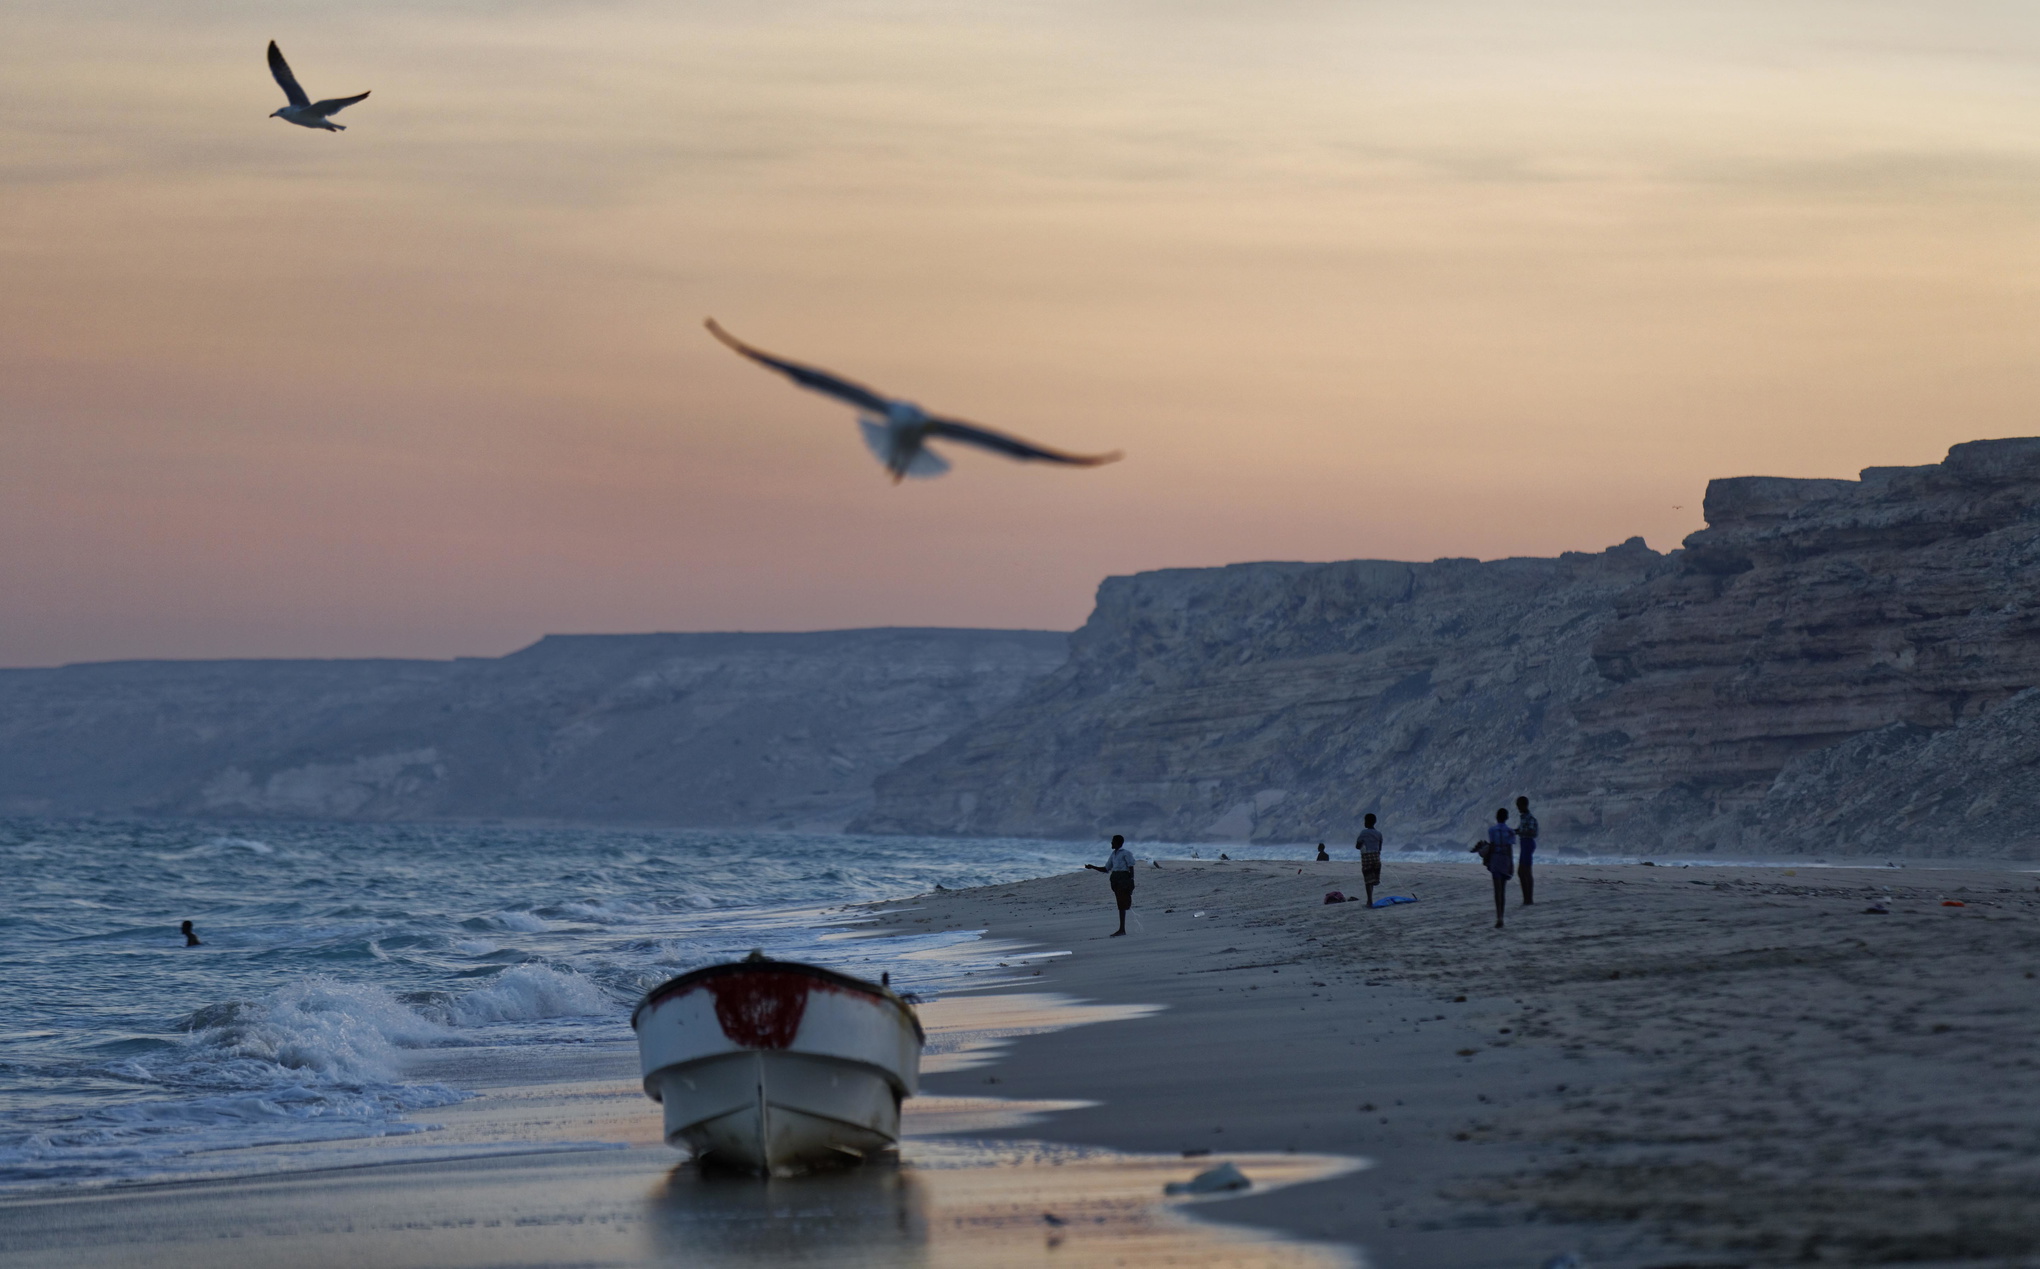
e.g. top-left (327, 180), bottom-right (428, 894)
top-left (0, 0), bottom-right (2040, 665)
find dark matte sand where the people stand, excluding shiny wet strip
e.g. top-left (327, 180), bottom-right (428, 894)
top-left (883, 857), bottom-right (2040, 1267)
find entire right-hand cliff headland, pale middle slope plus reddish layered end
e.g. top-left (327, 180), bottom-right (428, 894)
top-left (863, 439), bottom-right (2040, 855)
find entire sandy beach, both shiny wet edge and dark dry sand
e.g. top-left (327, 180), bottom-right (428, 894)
top-left (0, 859), bottom-right (2040, 1269)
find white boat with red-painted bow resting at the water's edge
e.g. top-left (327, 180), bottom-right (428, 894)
top-left (630, 953), bottom-right (924, 1175)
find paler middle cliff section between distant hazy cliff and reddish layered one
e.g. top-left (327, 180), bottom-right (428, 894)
top-left (861, 539), bottom-right (1671, 843)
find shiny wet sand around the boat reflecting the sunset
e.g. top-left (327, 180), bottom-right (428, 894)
top-left (0, 995), bottom-right (1365, 1269)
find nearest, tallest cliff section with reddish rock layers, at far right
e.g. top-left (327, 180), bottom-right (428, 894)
top-left (1567, 439), bottom-right (2040, 855)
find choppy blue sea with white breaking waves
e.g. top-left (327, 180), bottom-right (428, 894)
top-left (0, 820), bottom-right (1100, 1191)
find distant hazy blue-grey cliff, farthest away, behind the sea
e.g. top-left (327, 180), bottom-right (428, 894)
top-left (0, 630), bottom-right (1067, 830)
